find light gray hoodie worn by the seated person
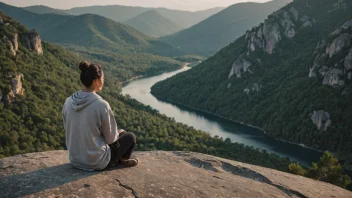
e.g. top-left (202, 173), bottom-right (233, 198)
top-left (62, 91), bottom-right (119, 171)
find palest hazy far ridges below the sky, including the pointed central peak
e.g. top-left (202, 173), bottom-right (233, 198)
top-left (25, 5), bottom-right (223, 37)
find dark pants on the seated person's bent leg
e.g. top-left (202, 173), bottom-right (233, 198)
top-left (107, 132), bottom-right (136, 168)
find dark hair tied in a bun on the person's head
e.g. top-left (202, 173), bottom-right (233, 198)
top-left (79, 61), bottom-right (103, 87)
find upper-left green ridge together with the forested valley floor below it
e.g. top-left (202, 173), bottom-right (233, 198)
top-left (0, 3), bottom-right (187, 81)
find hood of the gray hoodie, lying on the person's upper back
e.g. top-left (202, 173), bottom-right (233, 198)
top-left (70, 91), bottom-right (101, 111)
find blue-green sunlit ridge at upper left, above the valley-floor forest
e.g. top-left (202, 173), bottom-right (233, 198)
top-left (0, 3), bottom-right (182, 56)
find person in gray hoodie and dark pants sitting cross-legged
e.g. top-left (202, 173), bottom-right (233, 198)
top-left (62, 62), bottom-right (138, 171)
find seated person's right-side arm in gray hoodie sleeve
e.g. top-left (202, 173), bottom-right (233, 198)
top-left (102, 106), bottom-right (119, 144)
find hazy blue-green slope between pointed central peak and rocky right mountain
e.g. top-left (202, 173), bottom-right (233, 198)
top-left (161, 0), bottom-right (291, 56)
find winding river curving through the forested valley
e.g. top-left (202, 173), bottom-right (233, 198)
top-left (122, 67), bottom-right (322, 166)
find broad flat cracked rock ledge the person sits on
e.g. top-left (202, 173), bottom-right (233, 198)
top-left (0, 151), bottom-right (352, 198)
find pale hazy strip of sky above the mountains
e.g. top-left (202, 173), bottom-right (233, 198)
top-left (0, 0), bottom-right (269, 11)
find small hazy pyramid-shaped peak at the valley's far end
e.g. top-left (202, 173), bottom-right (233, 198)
top-left (125, 10), bottom-right (183, 37)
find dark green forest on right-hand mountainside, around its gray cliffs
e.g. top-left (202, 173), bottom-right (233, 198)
top-left (151, 0), bottom-right (352, 168)
